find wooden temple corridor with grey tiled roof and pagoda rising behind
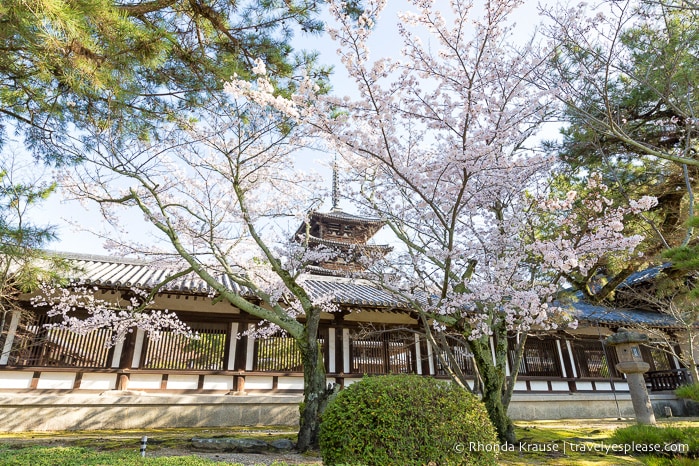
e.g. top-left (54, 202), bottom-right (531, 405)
top-left (0, 208), bottom-right (699, 431)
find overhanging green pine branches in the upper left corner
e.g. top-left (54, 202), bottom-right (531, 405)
top-left (0, 0), bottom-right (329, 163)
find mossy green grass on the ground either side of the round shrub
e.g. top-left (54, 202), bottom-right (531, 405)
top-left (0, 418), bottom-right (699, 466)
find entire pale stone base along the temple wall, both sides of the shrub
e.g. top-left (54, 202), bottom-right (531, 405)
top-left (0, 390), bottom-right (688, 432)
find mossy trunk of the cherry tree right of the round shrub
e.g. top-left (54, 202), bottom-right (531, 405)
top-left (469, 337), bottom-right (516, 443)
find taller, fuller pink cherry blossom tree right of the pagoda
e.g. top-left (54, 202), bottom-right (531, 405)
top-left (229, 0), bottom-right (652, 441)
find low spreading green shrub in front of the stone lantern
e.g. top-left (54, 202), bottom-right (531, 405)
top-left (609, 425), bottom-right (699, 458)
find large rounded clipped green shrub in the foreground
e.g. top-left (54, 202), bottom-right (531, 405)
top-left (319, 375), bottom-right (497, 466)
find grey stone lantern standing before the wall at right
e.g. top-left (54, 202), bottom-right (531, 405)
top-left (606, 328), bottom-right (655, 425)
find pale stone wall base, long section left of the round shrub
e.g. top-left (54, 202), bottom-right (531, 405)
top-left (0, 391), bottom-right (303, 432)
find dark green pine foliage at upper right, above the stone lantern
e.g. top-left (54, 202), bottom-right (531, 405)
top-left (552, 2), bottom-right (699, 258)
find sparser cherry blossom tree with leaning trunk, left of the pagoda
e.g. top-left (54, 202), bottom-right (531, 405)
top-left (52, 93), bottom-right (335, 450)
